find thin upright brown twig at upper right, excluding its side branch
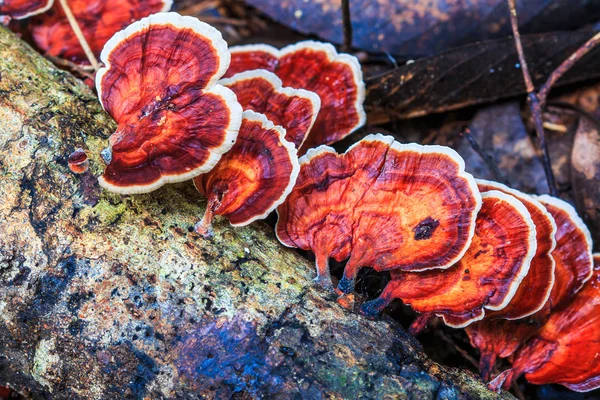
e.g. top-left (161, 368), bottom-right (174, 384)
top-left (508, 0), bottom-right (558, 196)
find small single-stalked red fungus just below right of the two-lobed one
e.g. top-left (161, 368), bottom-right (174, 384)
top-left (194, 111), bottom-right (300, 236)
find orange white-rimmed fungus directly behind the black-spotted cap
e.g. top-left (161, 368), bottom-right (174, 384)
top-left (362, 190), bottom-right (536, 333)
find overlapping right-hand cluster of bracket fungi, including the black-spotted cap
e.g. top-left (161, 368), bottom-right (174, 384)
top-left (276, 135), bottom-right (600, 390)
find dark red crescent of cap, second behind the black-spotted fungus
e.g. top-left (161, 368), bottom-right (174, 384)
top-left (477, 180), bottom-right (557, 320)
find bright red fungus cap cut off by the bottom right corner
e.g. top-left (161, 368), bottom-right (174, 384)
top-left (490, 254), bottom-right (600, 392)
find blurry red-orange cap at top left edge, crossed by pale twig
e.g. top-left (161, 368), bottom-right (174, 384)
top-left (31, 0), bottom-right (172, 64)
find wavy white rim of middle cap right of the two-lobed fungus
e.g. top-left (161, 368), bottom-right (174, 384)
top-left (219, 69), bottom-right (321, 148)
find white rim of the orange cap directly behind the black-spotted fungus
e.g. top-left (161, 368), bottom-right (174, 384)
top-left (436, 190), bottom-right (537, 329)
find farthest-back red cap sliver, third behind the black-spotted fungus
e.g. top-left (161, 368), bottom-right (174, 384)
top-left (535, 195), bottom-right (594, 310)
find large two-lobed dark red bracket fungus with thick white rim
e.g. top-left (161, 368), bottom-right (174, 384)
top-left (96, 13), bottom-right (242, 194)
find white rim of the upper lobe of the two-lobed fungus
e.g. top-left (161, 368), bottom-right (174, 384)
top-left (96, 12), bottom-right (231, 107)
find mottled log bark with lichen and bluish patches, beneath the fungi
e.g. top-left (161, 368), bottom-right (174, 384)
top-left (0, 27), bottom-right (510, 399)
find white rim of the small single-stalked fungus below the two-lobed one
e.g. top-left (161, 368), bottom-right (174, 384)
top-left (231, 110), bottom-right (300, 226)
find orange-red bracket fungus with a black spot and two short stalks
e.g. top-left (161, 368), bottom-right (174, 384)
top-left (276, 134), bottom-right (481, 293)
